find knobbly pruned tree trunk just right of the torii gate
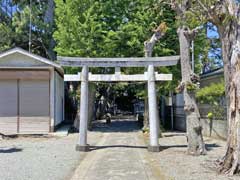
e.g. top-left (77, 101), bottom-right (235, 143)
top-left (172, 0), bottom-right (206, 155)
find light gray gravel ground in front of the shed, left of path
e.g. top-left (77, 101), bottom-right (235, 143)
top-left (0, 132), bottom-right (101, 180)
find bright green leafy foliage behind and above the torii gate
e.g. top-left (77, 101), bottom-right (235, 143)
top-left (54, 0), bottom-right (180, 98)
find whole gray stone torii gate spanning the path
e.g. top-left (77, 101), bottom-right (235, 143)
top-left (58, 56), bottom-right (179, 152)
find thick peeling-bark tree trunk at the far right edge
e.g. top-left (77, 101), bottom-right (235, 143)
top-left (194, 0), bottom-right (240, 175)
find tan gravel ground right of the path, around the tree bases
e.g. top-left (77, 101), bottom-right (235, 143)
top-left (144, 132), bottom-right (240, 180)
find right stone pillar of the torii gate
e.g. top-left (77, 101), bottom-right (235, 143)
top-left (148, 65), bottom-right (160, 152)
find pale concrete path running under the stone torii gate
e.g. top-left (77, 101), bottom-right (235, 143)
top-left (72, 120), bottom-right (165, 180)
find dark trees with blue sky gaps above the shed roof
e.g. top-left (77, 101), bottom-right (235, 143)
top-left (0, 0), bottom-right (55, 60)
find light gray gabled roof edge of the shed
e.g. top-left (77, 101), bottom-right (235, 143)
top-left (0, 47), bottom-right (64, 75)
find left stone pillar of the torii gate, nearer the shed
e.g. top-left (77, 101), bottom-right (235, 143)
top-left (76, 66), bottom-right (89, 151)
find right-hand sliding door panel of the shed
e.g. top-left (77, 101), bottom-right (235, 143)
top-left (19, 80), bottom-right (50, 134)
